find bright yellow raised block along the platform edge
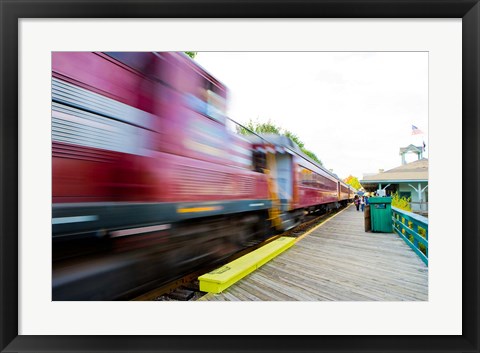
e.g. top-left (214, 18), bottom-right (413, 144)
top-left (198, 237), bottom-right (295, 293)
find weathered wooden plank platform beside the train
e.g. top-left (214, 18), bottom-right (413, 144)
top-left (199, 206), bottom-right (428, 301)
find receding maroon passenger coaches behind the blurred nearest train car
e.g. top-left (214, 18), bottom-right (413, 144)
top-left (248, 134), bottom-right (350, 230)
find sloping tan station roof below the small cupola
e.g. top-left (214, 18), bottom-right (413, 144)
top-left (360, 158), bottom-right (428, 184)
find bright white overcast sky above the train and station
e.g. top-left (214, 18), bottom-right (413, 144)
top-left (195, 52), bottom-right (428, 180)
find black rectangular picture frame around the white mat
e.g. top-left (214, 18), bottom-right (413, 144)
top-left (0, 0), bottom-right (480, 352)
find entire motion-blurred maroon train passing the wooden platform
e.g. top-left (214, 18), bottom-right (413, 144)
top-left (52, 52), bottom-right (354, 300)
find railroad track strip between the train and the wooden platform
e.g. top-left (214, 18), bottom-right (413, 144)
top-left (132, 206), bottom-right (348, 301)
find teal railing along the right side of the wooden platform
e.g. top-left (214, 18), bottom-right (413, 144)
top-left (392, 206), bottom-right (428, 266)
